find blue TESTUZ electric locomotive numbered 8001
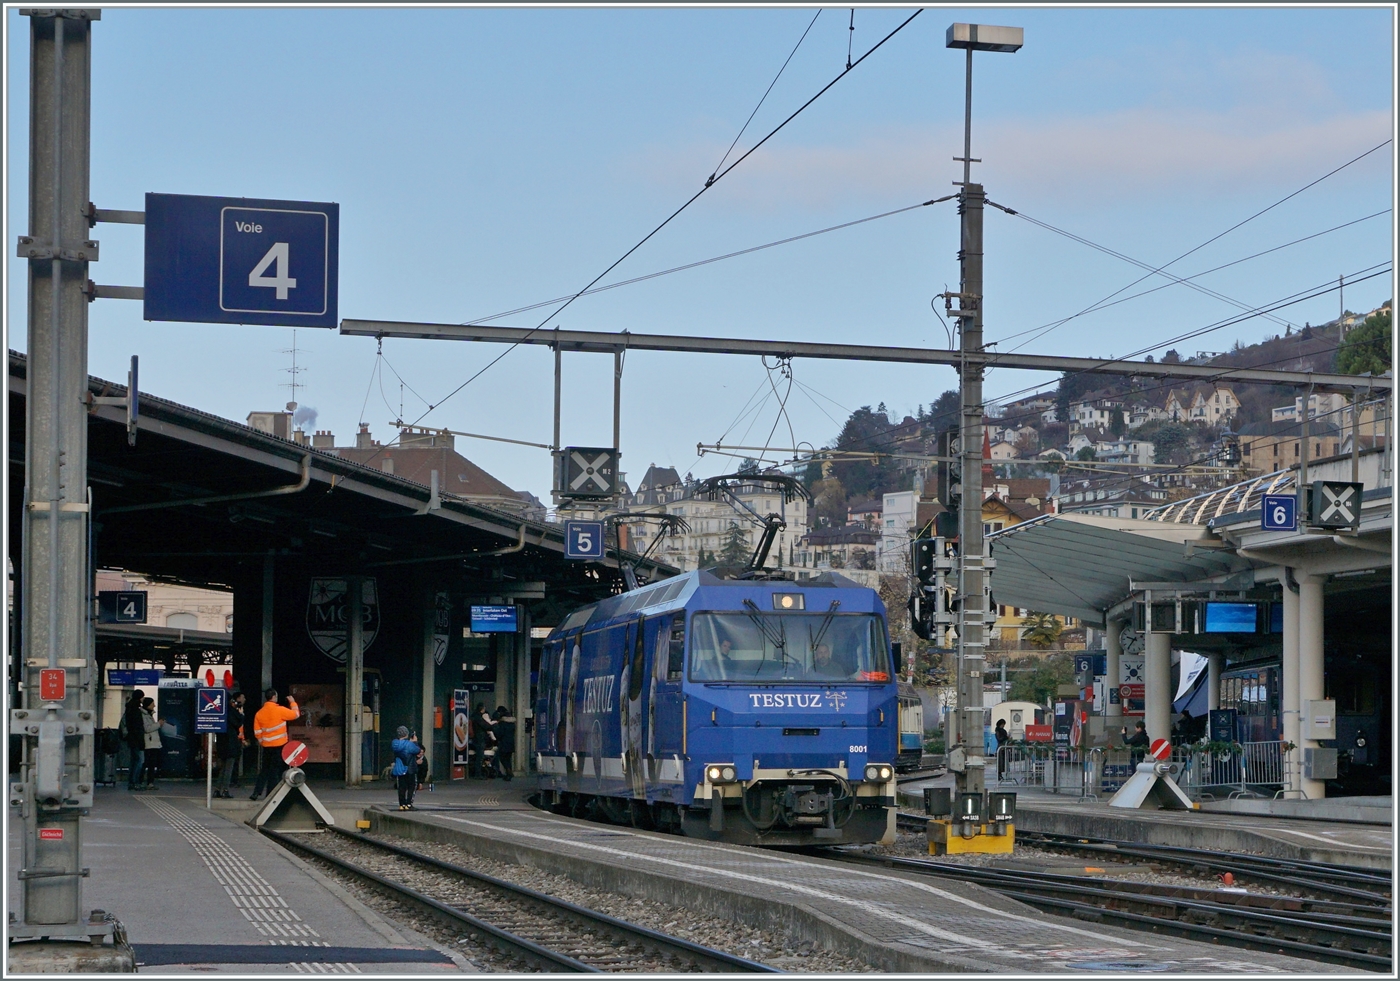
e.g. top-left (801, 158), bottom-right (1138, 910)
top-left (533, 570), bottom-right (899, 845)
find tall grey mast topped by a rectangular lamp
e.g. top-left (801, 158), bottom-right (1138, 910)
top-left (946, 24), bottom-right (1025, 811)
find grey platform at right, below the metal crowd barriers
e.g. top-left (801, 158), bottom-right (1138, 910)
top-left (899, 774), bottom-right (1394, 869)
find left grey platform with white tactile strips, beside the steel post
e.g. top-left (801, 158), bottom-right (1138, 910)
top-left (8, 784), bottom-right (468, 977)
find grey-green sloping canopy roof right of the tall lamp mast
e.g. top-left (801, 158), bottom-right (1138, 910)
top-left (987, 512), bottom-right (1250, 624)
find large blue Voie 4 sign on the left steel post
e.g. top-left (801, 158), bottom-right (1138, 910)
top-left (144, 195), bottom-right (340, 327)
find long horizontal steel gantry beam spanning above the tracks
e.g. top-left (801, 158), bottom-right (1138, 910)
top-left (340, 319), bottom-right (1394, 392)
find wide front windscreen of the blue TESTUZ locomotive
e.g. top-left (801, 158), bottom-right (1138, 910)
top-left (690, 610), bottom-right (892, 684)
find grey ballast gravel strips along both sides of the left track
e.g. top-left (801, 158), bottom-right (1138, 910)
top-left (305, 834), bottom-right (876, 974)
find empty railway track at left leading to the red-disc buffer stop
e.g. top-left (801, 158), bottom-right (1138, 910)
top-left (263, 828), bottom-right (781, 974)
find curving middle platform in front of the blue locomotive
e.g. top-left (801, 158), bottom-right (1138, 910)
top-left (371, 809), bottom-right (1345, 975)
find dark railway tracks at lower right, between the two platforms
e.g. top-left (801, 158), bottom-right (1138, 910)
top-left (862, 816), bottom-right (1393, 971)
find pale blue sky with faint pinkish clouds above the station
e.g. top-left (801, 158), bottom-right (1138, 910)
top-left (6, 6), bottom-right (1396, 500)
